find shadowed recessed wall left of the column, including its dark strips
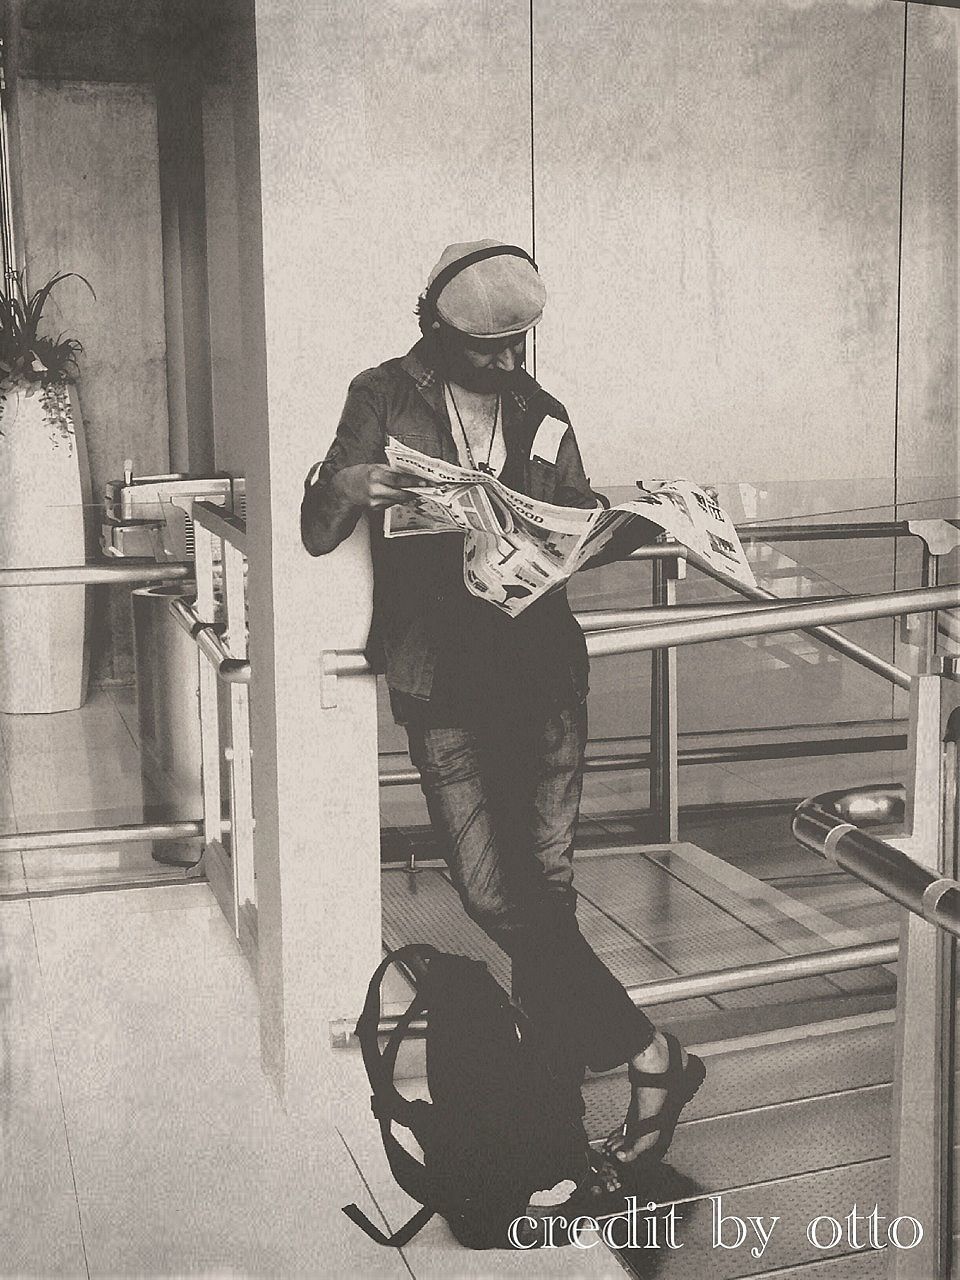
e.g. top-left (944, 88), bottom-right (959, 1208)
top-left (9, 0), bottom-right (241, 680)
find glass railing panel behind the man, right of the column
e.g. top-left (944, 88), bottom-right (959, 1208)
top-left (381, 479), bottom-right (960, 839)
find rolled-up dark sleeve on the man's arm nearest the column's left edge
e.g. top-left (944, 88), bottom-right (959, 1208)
top-left (300, 370), bottom-right (385, 556)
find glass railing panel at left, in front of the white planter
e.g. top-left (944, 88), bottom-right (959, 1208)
top-left (0, 500), bottom-right (212, 893)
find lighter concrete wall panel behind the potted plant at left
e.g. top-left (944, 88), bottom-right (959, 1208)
top-left (17, 78), bottom-right (169, 681)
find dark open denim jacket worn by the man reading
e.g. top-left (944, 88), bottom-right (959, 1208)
top-left (301, 338), bottom-right (607, 699)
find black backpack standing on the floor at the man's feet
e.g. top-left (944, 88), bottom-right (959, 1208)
top-left (343, 943), bottom-right (586, 1249)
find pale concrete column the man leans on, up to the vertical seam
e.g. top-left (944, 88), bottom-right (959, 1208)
top-left (244, 0), bottom-right (530, 1110)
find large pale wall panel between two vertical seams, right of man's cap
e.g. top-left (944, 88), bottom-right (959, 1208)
top-left (534, 0), bottom-right (904, 499)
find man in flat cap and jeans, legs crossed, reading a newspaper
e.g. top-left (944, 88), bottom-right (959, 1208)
top-left (301, 241), bottom-right (703, 1212)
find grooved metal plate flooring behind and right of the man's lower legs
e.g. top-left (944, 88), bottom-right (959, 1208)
top-left (381, 850), bottom-right (893, 1280)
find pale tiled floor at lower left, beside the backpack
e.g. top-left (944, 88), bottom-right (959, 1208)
top-left (0, 883), bottom-right (620, 1277)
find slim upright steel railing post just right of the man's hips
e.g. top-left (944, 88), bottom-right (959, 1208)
top-left (650, 559), bottom-right (680, 841)
